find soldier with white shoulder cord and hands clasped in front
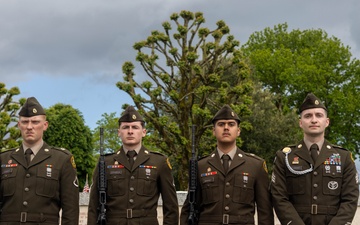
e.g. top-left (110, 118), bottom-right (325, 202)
top-left (271, 93), bottom-right (359, 225)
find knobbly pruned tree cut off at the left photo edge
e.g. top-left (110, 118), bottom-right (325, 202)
top-left (0, 83), bottom-right (26, 150)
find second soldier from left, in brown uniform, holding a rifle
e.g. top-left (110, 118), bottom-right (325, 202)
top-left (88, 106), bottom-right (179, 225)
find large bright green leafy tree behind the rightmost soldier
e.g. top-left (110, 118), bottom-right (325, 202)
top-left (242, 23), bottom-right (360, 152)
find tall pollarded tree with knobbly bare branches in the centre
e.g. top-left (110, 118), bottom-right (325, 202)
top-left (117, 11), bottom-right (252, 190)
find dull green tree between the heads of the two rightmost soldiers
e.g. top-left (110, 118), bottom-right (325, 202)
top-left (240, 83), bottom-right (302, 174)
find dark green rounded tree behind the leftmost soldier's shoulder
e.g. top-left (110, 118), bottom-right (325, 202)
top-left (44, 103), bottom-right (95, 190)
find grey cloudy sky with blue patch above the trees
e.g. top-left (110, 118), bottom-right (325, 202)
top-left (0, 0), bottom-right (360, 132)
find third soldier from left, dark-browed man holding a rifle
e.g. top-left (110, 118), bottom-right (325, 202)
top-left (180, 105), bottom-right (274, 225)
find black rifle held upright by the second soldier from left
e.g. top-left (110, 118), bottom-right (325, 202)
top-left (97, 127), bottom-right (106, 225)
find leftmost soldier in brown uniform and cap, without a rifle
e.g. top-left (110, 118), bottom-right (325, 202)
top-left (0, 97), bottom-right (79, 225)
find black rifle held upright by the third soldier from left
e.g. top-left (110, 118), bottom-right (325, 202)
top-left (188, 125), bottom-right (198, 225)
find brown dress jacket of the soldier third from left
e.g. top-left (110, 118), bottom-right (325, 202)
top-left (180, 148), bottom-right (274, 225)
